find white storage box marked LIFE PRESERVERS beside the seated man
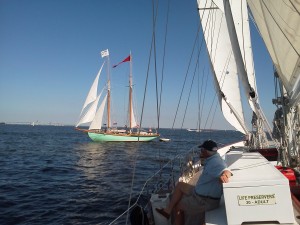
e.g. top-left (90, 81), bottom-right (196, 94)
top-left (223, 151), bottom-right (295, 225)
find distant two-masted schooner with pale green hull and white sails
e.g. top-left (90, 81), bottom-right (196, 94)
top-left (76, 49), bottom-right (159, 142)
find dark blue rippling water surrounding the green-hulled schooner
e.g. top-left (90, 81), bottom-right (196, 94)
top-left (0, 125), bottom-right (242, 225)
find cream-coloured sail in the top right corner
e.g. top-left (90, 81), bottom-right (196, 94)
top-left (247, 0), bottom-right (300, 103)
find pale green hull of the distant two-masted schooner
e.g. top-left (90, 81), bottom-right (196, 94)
top-left (88, 132), bottom-right (159, 142)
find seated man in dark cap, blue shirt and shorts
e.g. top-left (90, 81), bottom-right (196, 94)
top-left (156, 140), bottom-right (232, 225)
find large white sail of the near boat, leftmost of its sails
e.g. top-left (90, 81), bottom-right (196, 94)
top-left (198, 0), bottom-right (248, 133)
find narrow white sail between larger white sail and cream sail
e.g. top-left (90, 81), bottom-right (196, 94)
top-left (223, 0), bottom-right (271, 148)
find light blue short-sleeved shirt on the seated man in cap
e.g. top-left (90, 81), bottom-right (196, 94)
top-left (195, 153), bottom-right (227, 198)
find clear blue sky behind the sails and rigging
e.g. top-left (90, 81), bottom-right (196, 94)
top-left (0, 0), bottom-right (275, 129)
